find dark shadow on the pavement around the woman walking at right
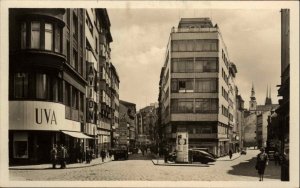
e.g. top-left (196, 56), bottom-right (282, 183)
top-left (228, 157), bottom-right (280, 179)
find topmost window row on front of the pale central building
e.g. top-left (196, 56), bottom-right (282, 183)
top-left (172, 39), bottom-right (218, 52)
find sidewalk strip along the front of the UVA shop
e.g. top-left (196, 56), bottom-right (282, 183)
top-left (9, 157), bottom-right (113, 170)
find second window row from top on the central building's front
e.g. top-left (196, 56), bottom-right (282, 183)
top-left (171, 57), bottom-right (218, 73)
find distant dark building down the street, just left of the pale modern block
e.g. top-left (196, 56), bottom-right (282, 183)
top-left (136, 103), bottom-right (158, 145)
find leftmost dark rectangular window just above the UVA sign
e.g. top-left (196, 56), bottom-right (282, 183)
top-left (14, 73), bottom-right (28, 98)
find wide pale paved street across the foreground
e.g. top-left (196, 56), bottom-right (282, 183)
top-left (9, 150), bottom-right (280, 181)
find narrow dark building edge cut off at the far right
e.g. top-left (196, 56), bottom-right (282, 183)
top-left (276, 9), bottom-right (290, 181)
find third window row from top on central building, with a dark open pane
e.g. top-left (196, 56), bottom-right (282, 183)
top-left (171, 78), bottom-right (218, 93)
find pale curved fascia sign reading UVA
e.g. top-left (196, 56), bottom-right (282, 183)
top-left (9, 101), bottom-right (80, 131)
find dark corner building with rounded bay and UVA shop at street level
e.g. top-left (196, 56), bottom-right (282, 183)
top-left (9, 9), bottom-right (90, 163)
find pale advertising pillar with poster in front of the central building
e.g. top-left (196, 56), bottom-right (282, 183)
top-left (176, 132), bottom-right (189, 162)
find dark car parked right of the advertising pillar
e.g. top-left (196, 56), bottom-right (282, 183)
top-left (189, 149), bottom-right (216, 164)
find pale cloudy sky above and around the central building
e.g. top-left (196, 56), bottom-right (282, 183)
top-left (107, 8), bottom-right (281, 109)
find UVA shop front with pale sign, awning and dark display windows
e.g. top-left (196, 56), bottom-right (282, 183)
top-left (9, 101), bottom-right (90, 164)
